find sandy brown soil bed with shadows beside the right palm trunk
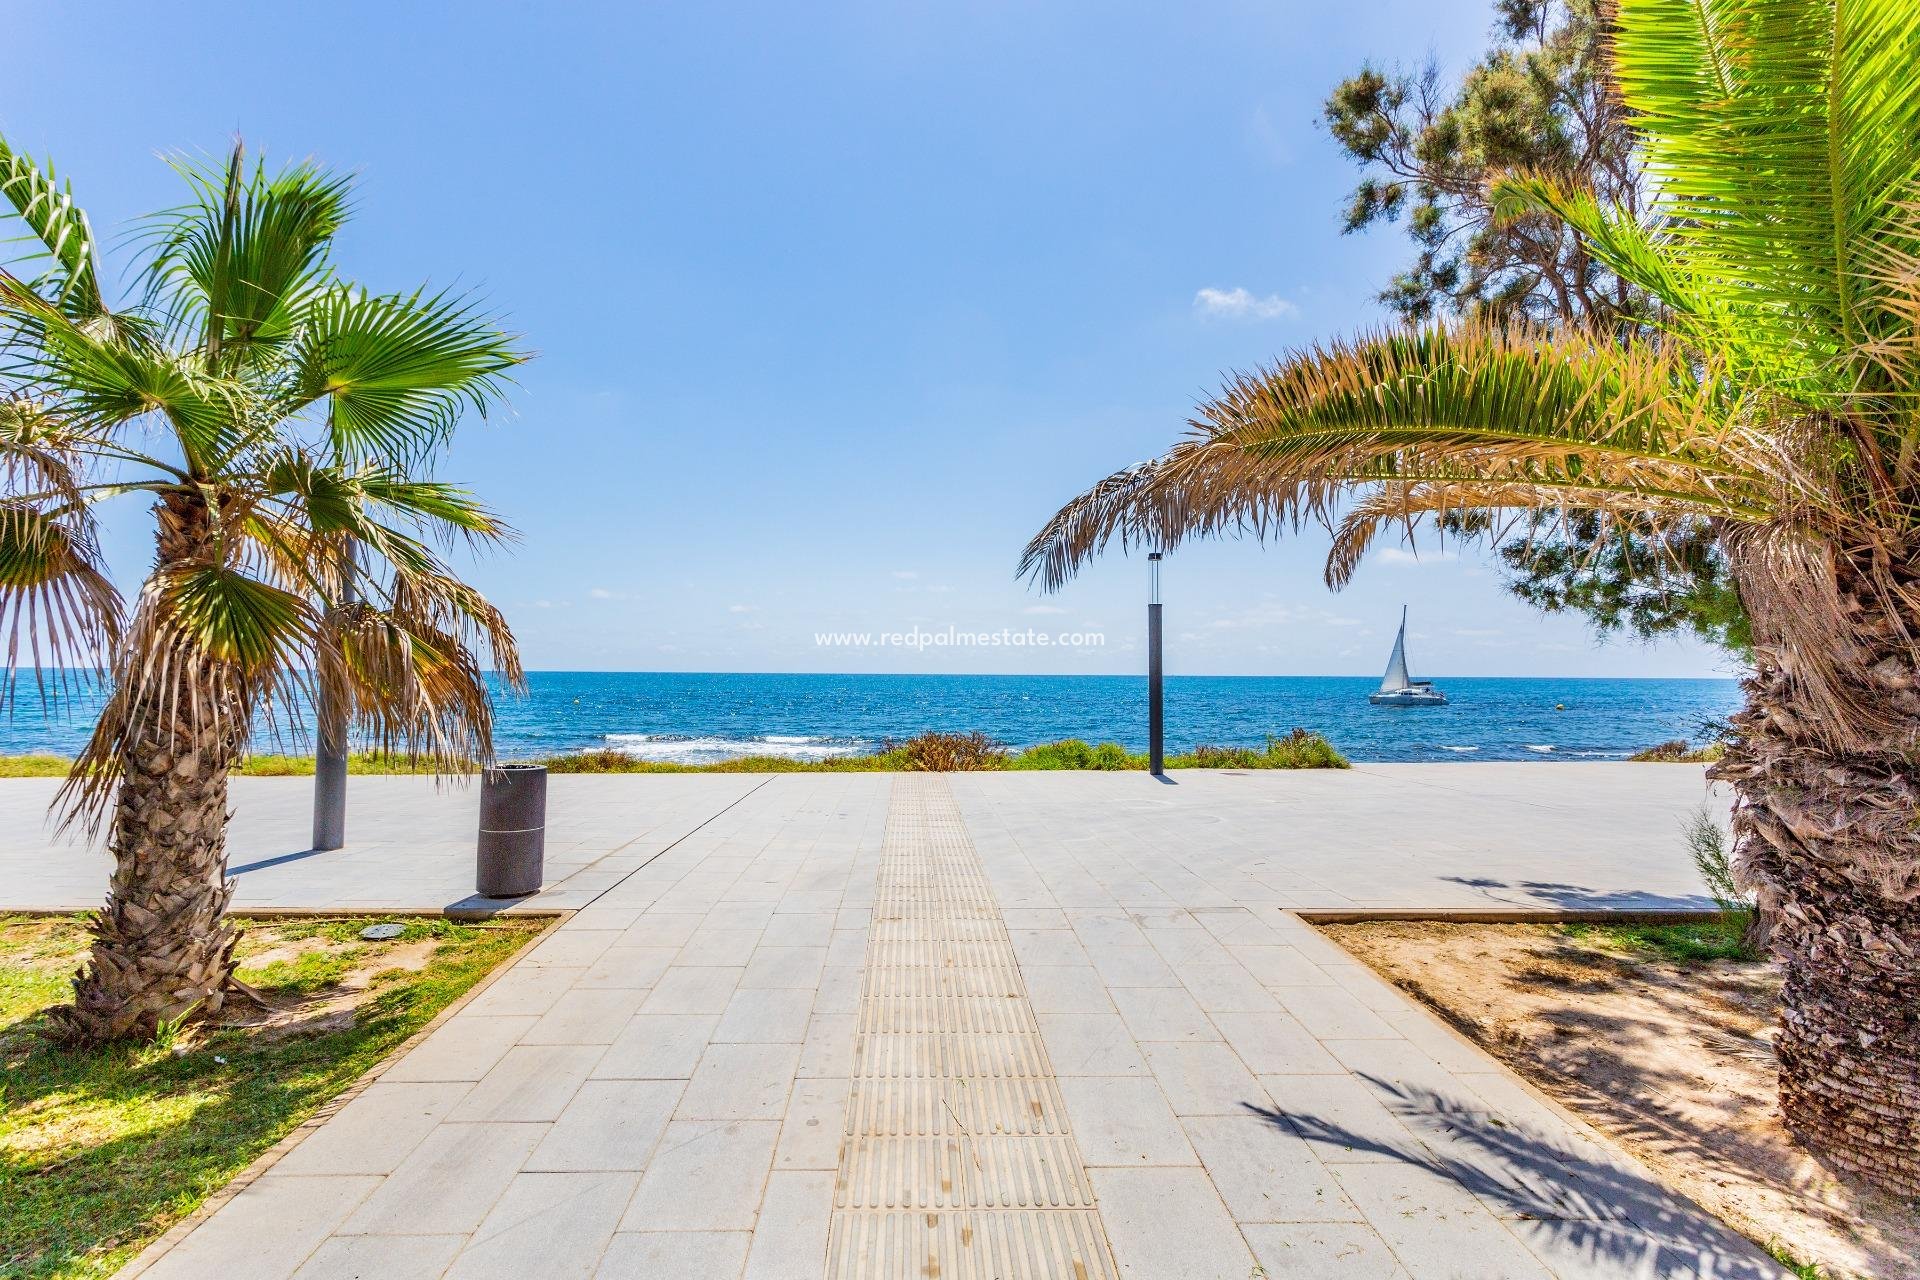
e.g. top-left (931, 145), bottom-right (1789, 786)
top-left (1325, 921), bottom-right (1920, 1280)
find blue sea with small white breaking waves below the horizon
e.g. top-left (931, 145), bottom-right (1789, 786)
top-left (0, 672), bottom-right (1740, 764)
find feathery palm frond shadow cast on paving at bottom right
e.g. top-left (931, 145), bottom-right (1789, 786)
top-left (1248, 1073), bottom-right (1786, 1280)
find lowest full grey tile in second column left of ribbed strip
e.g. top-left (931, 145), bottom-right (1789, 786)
top-left (620, 1121), bottom-right (780, 1232)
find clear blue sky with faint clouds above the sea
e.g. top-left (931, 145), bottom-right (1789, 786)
top-left (0, 0), bottom-right (1726, 676)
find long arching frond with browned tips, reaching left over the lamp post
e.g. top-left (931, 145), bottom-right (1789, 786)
top-left (1020, 326), bottom-right (1781, 589)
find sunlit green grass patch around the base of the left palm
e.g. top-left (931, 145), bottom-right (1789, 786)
top-left (0, 915), bottom-right (541, 1280)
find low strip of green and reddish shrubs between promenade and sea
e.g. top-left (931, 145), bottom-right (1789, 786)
top-left (0, 729), bottom-right (1352, 777)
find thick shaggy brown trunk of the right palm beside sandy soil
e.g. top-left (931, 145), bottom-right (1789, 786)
top-left (1713, 562), bottom-right (1920, 1196)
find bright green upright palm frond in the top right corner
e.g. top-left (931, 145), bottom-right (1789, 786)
top-left (1615, 0), bottom-right (1920, 399)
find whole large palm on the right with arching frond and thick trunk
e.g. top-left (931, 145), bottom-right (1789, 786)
top-left (1021, 0), bottom-right (1920, 1196)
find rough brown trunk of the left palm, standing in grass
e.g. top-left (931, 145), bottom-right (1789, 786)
top-left (52, 495), bottom-right (248, 1044)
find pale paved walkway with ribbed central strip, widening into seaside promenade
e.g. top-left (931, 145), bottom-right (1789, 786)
top-left (37, 766), bottom-right (1782, 1280)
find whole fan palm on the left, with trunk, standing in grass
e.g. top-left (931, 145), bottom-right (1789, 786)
top-left (0, 140), bottom-right (524, 1042)
